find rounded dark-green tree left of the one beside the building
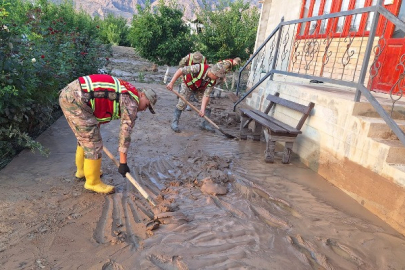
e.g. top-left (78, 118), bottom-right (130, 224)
top-left (129, 0), bottom-right (193, 65)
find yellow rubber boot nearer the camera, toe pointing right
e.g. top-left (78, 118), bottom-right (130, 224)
top-left (84, 158), bottom-right (115, 194)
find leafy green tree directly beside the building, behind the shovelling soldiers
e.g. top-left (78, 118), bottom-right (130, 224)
top-left (197, 0), bottom-right (260, 61)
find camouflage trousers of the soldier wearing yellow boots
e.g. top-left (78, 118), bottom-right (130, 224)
top-left (59, 80), bottom-right (103, 160)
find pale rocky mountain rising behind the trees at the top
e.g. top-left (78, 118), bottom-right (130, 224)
top-left (51, 0), bottom-right (260, 20)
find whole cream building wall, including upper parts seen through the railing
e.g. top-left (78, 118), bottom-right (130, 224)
top-left (246, 0), bottom-right (405, 235)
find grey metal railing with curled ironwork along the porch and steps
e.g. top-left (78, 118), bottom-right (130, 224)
top-left (233, 0), bottom-right (405, 145)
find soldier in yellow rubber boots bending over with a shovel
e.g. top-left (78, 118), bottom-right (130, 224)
top-left (59, 74), bottom-right (157, 194)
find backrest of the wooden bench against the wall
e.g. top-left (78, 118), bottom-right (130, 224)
top-left (264, 92), bottom-right (315, 130)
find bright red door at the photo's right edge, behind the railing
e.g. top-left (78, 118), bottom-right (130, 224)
top-left (371, 0), bottom-right (405, 94)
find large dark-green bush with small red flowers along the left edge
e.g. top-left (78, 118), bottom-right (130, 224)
top-left (0, 0), bottom-right (111, 169)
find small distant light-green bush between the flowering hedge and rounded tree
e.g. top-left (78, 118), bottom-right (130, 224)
top-left (96, 14), bottom-right (130, 46)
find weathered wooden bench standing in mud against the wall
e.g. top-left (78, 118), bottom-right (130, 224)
top-left (240, 92), bottom-right (315, 164)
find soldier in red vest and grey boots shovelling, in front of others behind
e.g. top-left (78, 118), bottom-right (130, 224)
top-left (166, 61), bottom-right (225, 132)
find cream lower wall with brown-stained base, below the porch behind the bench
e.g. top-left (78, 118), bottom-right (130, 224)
top-left (246, 78), bottom-right (405, 235)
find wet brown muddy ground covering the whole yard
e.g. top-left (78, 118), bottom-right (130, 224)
top-left (0, 47), bottom-right (405, 270)
